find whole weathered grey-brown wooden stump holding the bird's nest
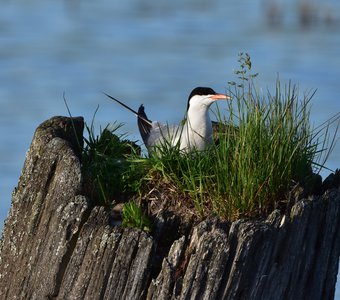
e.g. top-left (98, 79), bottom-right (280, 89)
top-left (0, 117), bottom-right (340, 299)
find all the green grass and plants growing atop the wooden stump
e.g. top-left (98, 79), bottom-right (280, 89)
top-left (77, 54), bottom-right (339, 228)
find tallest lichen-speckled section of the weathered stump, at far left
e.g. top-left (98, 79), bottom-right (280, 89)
top-left (0, 118), bottom-right (88, 299)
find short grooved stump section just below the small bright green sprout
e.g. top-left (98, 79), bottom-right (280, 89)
top-left (57, 207), bottom-right (154, 299)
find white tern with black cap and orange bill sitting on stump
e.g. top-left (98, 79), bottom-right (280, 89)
top-left (104, 87), bottom-right (230, 152)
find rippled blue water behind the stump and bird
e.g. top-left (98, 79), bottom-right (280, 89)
top-left (0, 0), bottom-right (340, 299)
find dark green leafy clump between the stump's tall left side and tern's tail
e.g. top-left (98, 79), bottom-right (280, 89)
top-left (82, 108), bottom-right (143, 207)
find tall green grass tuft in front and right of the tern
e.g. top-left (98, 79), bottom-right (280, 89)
top-left (141, 54), bottom-right (338, 220)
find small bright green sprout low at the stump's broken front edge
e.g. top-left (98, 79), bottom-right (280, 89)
top-left (122, 201), bottom-right (152, 231)
